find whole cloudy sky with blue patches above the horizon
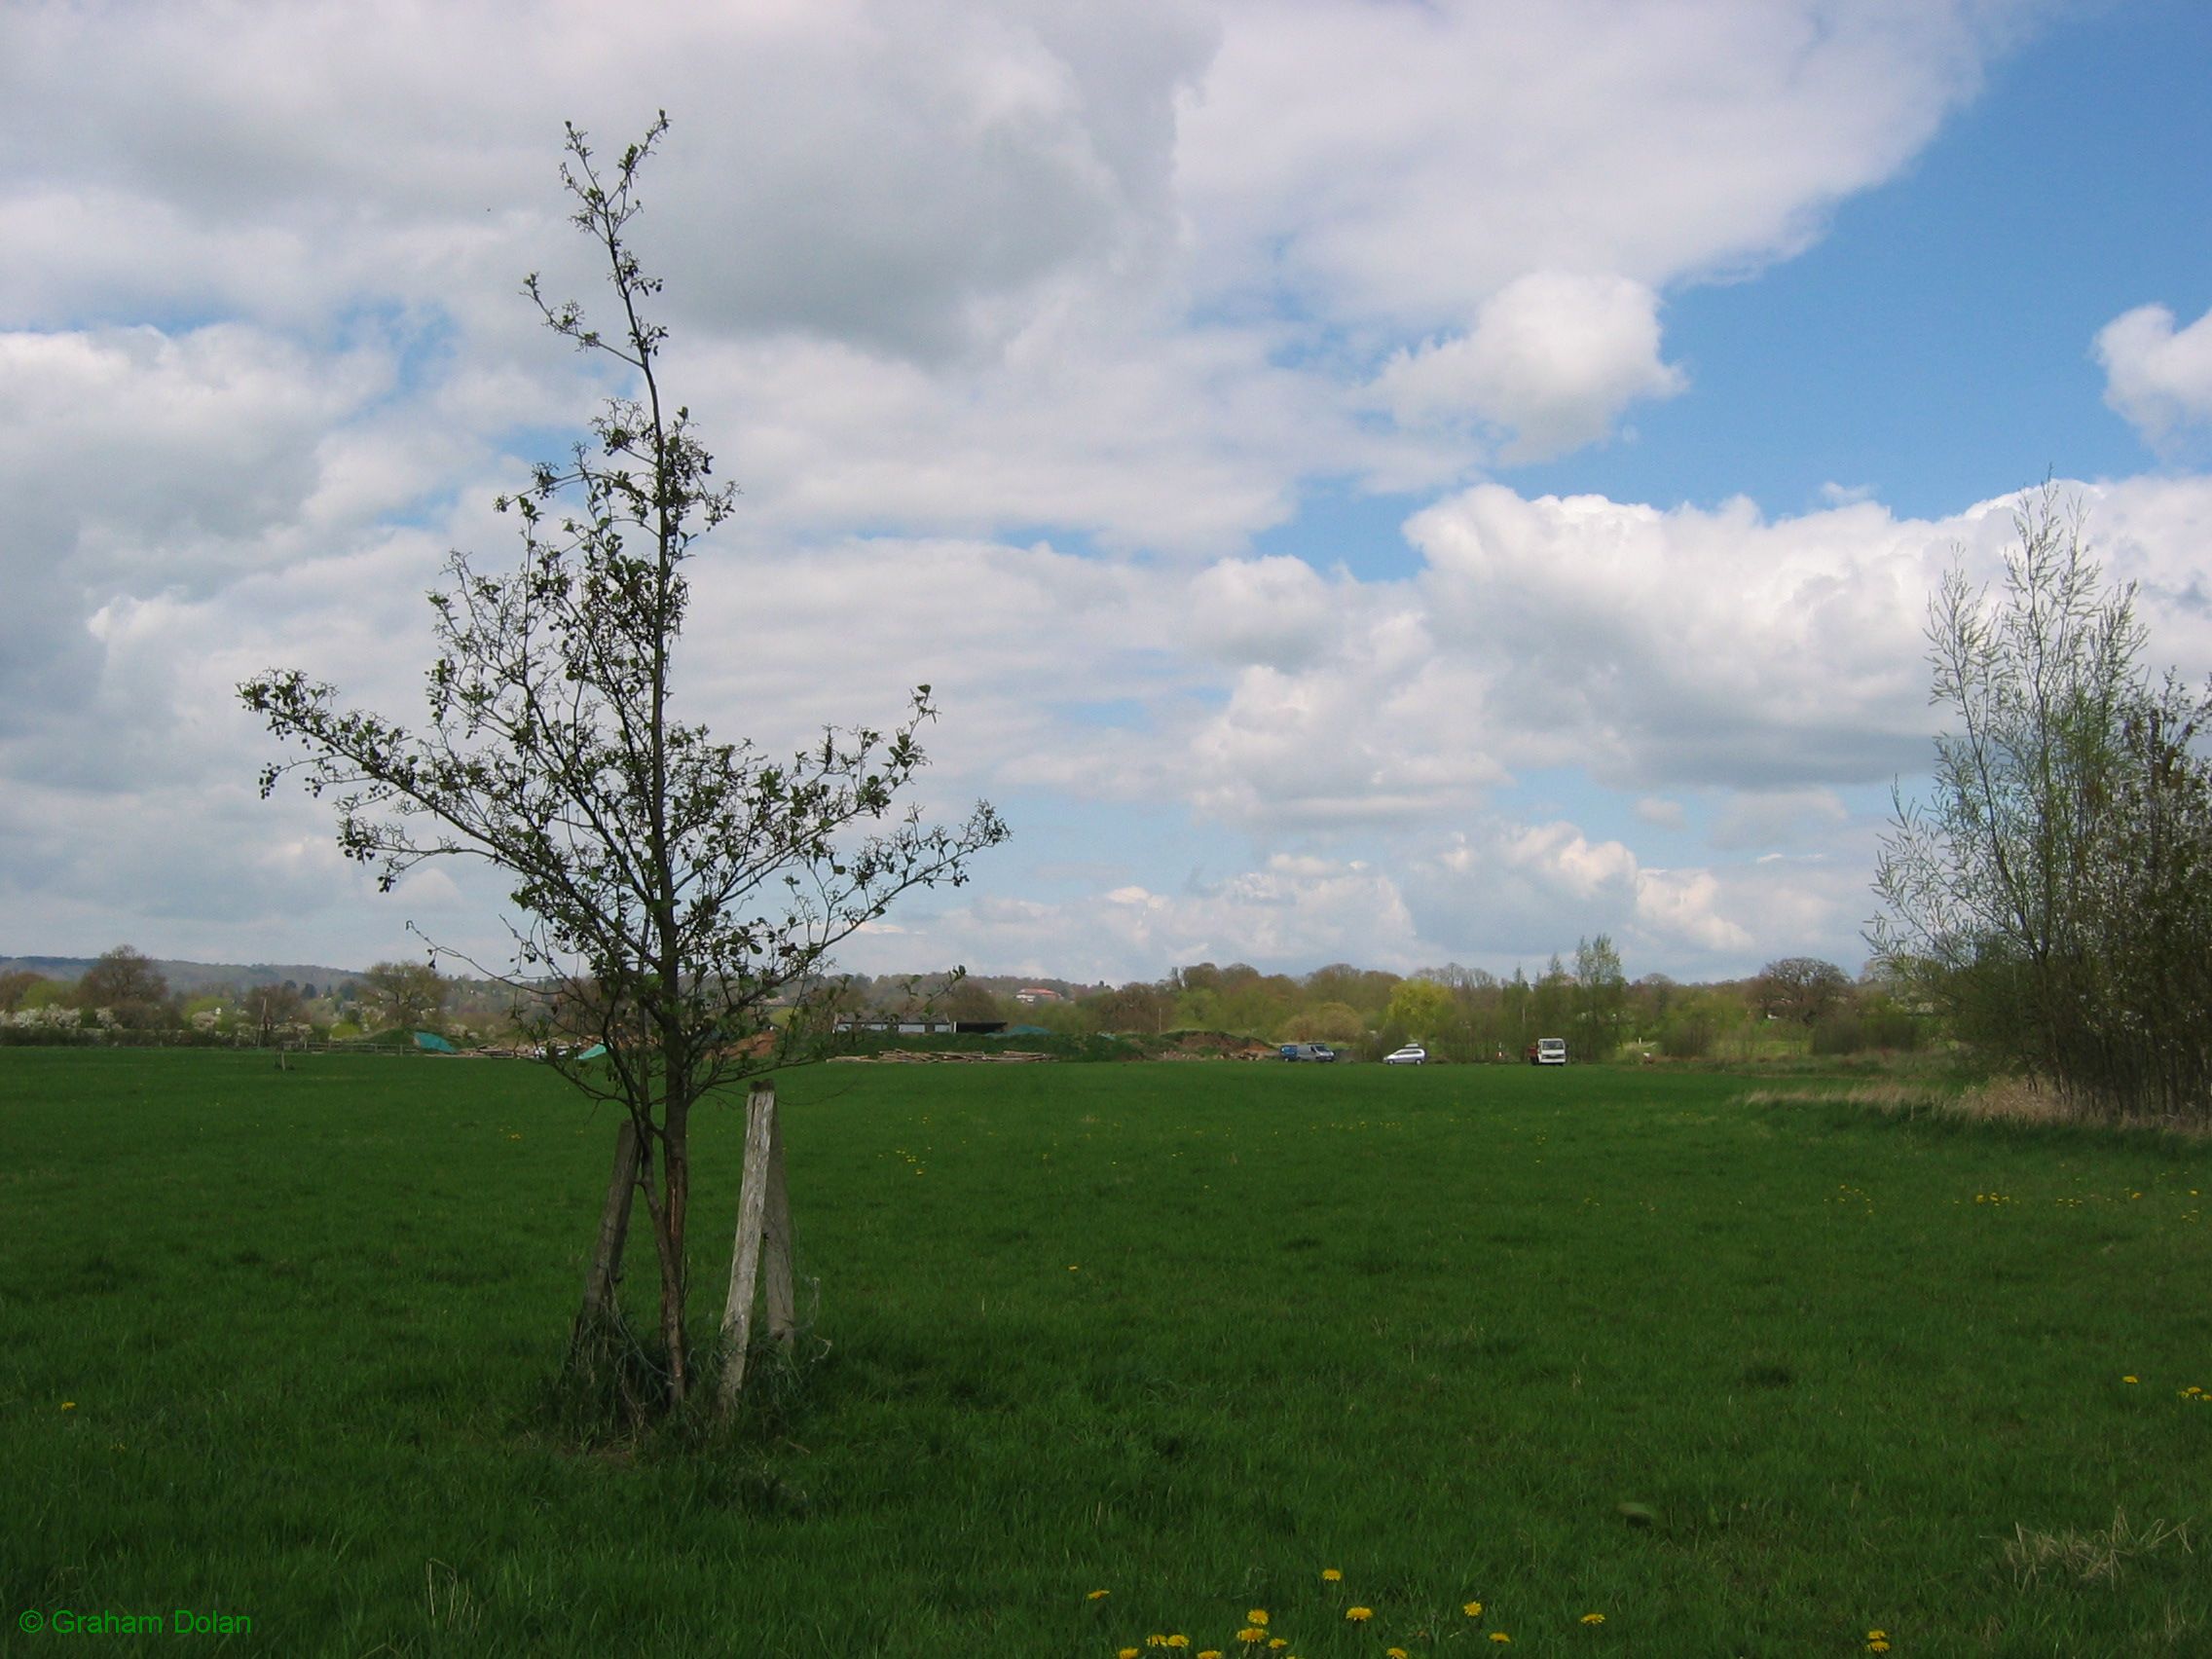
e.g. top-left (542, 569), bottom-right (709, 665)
top-left (0, 0), bottom-right (2212, 982)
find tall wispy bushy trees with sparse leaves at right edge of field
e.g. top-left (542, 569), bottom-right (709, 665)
top-left (1867, 487), bottom-right (2212, 1120)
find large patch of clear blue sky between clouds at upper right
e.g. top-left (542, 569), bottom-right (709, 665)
top-left (1513, 5), bottom-right (2212, 515)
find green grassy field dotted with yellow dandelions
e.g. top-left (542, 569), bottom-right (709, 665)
top-left (0, 1051), bottom-right (2212, 1659)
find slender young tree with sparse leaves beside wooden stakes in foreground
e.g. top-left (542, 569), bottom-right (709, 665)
top-left (239, 115), bottom-right (1007, 1412)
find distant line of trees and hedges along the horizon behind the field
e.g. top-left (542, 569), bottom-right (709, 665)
top-left (0, 934), bottom-right (1937, 1062)
